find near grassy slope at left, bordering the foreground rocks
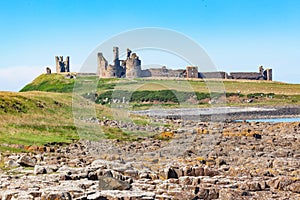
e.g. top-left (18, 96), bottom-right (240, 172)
top-left (0, 91), bottom-right (150, 152)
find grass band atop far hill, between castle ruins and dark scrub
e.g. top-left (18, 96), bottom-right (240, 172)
top-left (21, 74), bottom-right (300, 95)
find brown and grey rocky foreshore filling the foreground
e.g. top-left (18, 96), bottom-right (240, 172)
top-left (0, 120), bottom-right (300, 200)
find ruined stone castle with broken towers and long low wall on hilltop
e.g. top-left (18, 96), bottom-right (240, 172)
top-left (52, 47), bottom-right (272, 81)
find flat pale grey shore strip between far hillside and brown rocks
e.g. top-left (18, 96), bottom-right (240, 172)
top-left (132, 106), bottom-right (300, 121)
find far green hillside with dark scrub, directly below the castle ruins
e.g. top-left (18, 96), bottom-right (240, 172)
top-left (21, 74), bottom-right (300, 109)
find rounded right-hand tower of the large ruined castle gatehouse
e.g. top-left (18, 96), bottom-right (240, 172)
top-left (126, 50), bottom-right (142, 78)
